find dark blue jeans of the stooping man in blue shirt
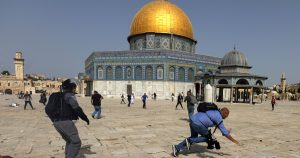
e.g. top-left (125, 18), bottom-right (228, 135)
top-left (175, 121), bottom-right (208, 151)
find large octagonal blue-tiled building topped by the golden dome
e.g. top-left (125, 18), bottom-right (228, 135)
top-left (83, 0), bottom-right (221, 98)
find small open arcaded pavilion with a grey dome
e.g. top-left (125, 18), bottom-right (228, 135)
top-left (197, 48), bottom-right (268, 103)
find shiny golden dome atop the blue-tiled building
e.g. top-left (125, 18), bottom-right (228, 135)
top-left (129, 0), bottom-right (194, 40)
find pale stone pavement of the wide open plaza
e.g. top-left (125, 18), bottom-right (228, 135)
top-left (0, 95), bottom-right (300, 158)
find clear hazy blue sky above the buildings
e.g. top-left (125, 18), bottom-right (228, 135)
top-left (0, 0), bottom-right (300, 85)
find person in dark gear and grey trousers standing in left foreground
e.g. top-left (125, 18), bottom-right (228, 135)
top-left (45, 79), bottom-right (90, 158)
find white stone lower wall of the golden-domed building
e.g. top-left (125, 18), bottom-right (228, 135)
top-left (92, 80), bottom-right (195, 99)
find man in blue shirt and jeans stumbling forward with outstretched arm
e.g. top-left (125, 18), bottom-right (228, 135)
top-left (172, 107), bottom-right (240, 157)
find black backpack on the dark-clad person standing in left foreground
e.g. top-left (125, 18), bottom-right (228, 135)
top-left (45, 92), bottom-right (64, 122)
